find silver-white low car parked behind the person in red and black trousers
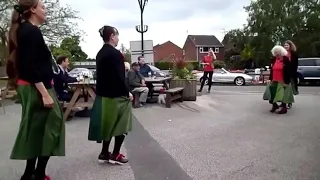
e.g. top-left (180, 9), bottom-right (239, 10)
top-left (196, 68), bottom-right (253, 86)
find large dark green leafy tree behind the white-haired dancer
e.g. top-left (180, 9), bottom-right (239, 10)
top-left (245, 0), bottom-right (320, 59)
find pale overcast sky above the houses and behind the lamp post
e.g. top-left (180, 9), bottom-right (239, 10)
top-left (60, 0), bottom-right (250, 58)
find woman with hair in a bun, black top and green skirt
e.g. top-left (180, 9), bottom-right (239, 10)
top-left (88, 26), bottom-right (132, 164)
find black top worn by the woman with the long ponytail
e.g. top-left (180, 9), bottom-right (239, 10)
top-left (16, 21), bottom-right (54, 88)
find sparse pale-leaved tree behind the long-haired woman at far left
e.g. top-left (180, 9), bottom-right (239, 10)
top-left (0, 0), bottom-right (81, 64)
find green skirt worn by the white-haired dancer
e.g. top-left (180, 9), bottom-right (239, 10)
top-left (263, 81), bottom-right (294, 104)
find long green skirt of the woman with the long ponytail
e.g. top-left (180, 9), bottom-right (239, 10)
top-left (10, 85), bottom-right (65, 160)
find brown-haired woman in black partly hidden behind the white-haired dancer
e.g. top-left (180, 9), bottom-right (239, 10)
top-left (284, 40), bottom-right (299, 108)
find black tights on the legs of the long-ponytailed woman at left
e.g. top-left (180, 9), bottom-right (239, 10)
top-left (21, 156), bottom-right (50, 180)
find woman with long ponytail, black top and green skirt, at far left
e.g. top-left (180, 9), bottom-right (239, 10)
top-left (7, 0), bottom-right (65, 180)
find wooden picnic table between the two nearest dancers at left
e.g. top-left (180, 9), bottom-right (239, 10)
top-left (63, 80), bottom-right (96, 120)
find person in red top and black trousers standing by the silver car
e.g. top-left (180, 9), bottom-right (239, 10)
top-left (198, 48), bottom-right (216, 93)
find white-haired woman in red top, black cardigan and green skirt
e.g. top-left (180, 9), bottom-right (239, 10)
top-left (267, 46), bottom-right (294, 114)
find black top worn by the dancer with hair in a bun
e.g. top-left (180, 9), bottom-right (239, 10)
top-left (96, 44), bottom-right (129, 98)
